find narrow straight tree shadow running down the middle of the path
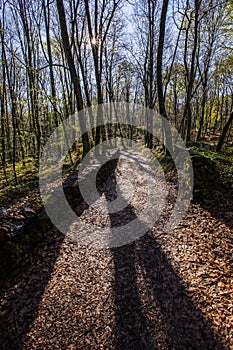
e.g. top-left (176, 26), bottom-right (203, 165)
top-left (99, 154), bottom-right (154, 350)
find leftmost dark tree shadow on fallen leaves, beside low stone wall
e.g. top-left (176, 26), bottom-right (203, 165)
top-left (0, 229), bottom-right (64, 350)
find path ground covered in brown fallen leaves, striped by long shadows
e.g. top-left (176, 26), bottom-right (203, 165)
top-left (0, 146), bottom-right (233, 350)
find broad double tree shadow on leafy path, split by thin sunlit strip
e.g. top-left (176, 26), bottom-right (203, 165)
top-left (99, 154), bottom-right (224, 350)
